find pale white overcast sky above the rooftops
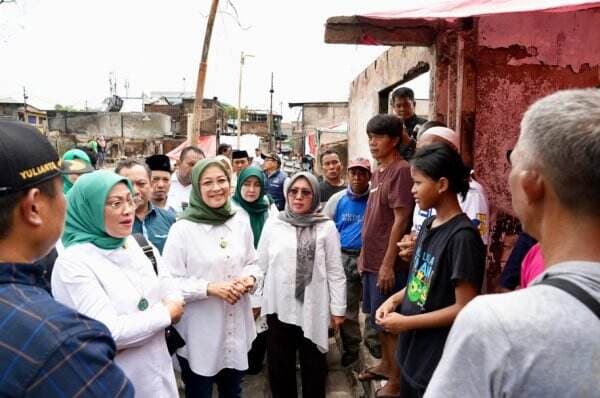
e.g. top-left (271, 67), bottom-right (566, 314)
top-left (0, 0), bottom-right (436, 121)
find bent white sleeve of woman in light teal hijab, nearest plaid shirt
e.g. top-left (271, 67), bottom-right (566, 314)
top-left (52, 257), bottom-right (171, 350)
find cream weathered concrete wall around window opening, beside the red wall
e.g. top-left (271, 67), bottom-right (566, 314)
top-left (348, 47), bottom-right (435, 162)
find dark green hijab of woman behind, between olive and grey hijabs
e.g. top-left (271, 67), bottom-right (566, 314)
top-left (233, 167), bottom-right (271, 248)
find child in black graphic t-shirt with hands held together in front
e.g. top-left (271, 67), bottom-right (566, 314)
top-left (376, 144), bottom-right (485, 397)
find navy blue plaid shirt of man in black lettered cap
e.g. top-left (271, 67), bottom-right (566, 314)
top-left (0, 263), bottom-right (134, 398)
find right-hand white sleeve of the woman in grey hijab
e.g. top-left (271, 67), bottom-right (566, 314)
top-left (323, 221), bottom-right (346, 316)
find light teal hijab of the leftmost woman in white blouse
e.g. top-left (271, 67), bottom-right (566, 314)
top-left (62, 170), bottom-right (133, 249)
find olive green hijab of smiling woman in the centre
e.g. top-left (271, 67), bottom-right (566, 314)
top-left (181, 159), bottom-right (235, 225)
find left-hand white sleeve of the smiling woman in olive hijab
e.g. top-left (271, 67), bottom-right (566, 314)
top-left (163, 223), bottom-right (208, 302)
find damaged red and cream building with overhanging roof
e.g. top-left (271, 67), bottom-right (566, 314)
top-left (325, 0), bottom-right (600, 289)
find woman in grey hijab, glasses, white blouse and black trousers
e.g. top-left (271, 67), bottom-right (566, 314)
top-left (258, 173), bottom-right (346, 398)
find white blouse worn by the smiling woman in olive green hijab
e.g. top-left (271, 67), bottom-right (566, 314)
top-left (164, 213), bottom-right (262, 376)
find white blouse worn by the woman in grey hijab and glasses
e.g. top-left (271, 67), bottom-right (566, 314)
top-left (258, 218), bottom-right (346, 352)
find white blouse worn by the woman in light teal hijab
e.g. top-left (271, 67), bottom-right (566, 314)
top-left (52, 236), bottom-right (181, 398)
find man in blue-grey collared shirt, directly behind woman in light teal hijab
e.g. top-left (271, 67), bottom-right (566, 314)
top-left (115, 159), bottom-right (175, 254)
